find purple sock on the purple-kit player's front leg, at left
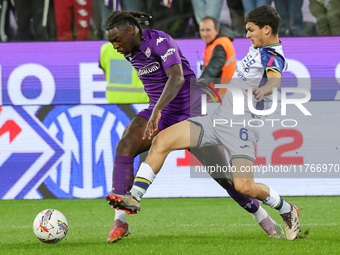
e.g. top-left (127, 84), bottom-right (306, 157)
top-left (112, 154), bottom-right (135, 195)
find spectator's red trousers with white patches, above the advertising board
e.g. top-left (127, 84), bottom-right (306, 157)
top-left (53, 0), bottom-right (92, 41)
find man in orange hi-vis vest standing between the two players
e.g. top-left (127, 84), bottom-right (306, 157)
top-left (199, 16), bottom-right (236, 95)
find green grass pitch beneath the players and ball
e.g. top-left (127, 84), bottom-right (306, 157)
top-left (0, 196), bottom-right (340, 255)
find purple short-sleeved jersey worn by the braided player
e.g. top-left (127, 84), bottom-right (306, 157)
top-left (125, 29), bottom-right (196, 112)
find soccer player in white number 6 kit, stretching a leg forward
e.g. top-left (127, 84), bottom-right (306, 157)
top-left (107, 5), bottom-right (301, 240)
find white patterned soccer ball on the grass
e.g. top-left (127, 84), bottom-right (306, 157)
top-left (33, 209), bottom-right (68, 243)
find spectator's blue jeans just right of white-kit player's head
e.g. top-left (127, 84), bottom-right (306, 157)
top-left (274, 0), bottom-right (305, 36)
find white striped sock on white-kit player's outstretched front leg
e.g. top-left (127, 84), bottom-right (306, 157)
top-left (130, 162), bottom-right (156, 201)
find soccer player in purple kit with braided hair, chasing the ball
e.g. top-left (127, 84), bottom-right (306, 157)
top-left (106, 11), bottom-right (284, 243)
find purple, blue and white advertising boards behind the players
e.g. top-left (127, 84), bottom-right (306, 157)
top-left (0, 37), bottom-right (340, 199)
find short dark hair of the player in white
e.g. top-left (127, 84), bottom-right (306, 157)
top-left (245, 5), bottom-right (281, 35)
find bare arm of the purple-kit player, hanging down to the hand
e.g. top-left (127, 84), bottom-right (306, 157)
top-left (143, 64), bottom-right (185, 139)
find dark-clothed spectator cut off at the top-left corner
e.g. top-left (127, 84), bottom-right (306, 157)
top-left (0, 0), bottom-right (14, 42)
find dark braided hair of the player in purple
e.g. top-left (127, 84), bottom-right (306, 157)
top-left (105, 11), bottom-right (152, 35)
